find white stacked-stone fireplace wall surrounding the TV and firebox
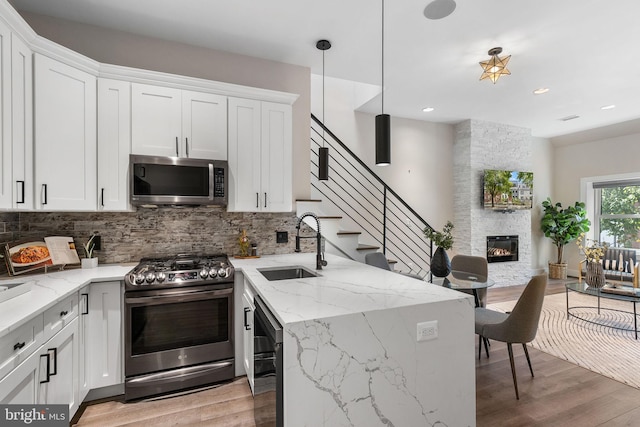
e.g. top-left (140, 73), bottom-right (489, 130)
top-left (453, 120), bottom-right (537, 286)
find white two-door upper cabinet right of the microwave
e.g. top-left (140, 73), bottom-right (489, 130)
top-left (228, 98), bottom-right (293, 212)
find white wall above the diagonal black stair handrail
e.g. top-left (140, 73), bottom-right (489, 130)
top-left (311, 75), bottom-right (453, 232)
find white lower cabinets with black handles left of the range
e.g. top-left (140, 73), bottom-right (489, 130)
top-left (0, 281), bottom-right (123, 417)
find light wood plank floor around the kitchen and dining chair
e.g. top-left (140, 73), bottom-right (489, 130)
top-left (72, 281), bottom-right (640, 427)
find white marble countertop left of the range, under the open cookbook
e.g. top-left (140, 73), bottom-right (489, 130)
top-left (0, 263), bottom-right (136, 337)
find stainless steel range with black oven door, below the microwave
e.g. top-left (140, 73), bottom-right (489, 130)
top-left (124, 255), bottom-right (235, 400)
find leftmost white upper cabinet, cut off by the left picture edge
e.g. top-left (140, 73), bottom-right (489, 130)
top-left (0, 22), bottom-right (33, 209)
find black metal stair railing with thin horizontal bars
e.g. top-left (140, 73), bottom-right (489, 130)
top-left (311, 114), bottom-right (433, 279)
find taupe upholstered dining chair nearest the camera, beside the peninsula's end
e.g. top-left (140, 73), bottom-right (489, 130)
top-left (475, 274), bottom-right (547, 400)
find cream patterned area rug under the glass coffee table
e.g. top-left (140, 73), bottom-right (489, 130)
top-left (487, 292), bottom-right (640, 389)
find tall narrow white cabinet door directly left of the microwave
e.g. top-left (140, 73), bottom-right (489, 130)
top-left (98, 79), bottom-right (131, 211)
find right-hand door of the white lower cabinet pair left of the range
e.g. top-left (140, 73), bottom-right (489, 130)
top-left (38, 318), bottom-right (79, 417)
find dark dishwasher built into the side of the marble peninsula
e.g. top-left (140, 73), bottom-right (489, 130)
top-left (253, 296), bottom-right (284, 427)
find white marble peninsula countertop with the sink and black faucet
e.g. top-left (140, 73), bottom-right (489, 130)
top-left (231, 253), bottom-right (464, 326)
